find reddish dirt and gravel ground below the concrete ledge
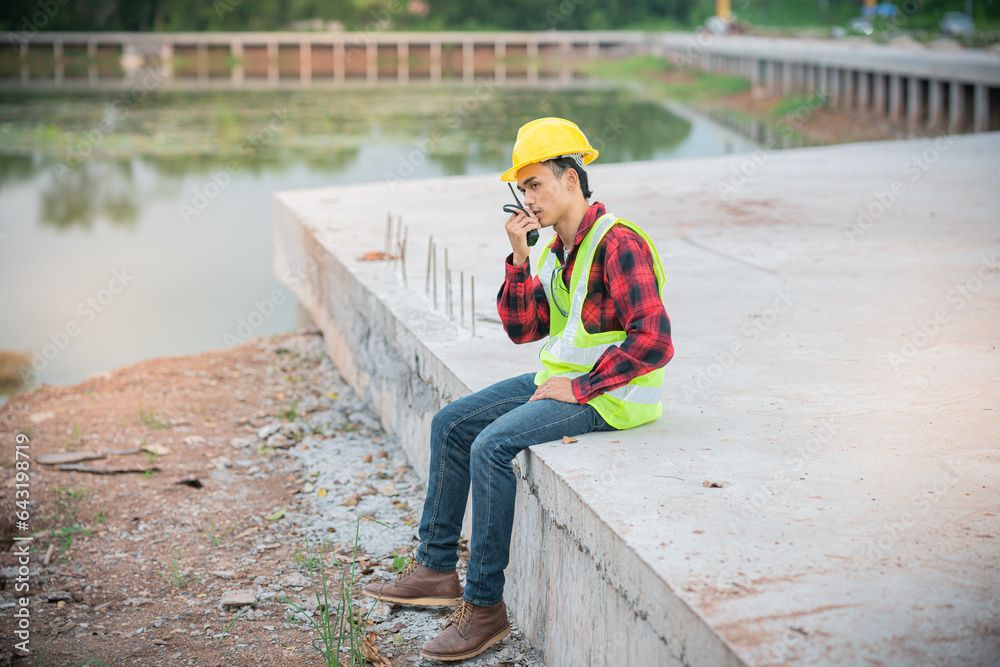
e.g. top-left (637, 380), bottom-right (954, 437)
top-left (0, 331), bottom-right (541, 667)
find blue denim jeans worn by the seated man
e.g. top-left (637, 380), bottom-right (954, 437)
top-left (417, 373), bottom-right (614, 606)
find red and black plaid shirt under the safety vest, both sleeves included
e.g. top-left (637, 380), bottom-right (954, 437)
top-left (497, 202), bottom-right (674, 403)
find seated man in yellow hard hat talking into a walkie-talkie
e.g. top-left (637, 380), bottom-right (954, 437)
top-left (364, 118), bottom-right (673, 660)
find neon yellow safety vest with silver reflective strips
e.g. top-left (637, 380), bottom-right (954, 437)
top-left (535, 214), bottom-right (664, 429)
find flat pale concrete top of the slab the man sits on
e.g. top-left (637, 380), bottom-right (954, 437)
top-left (276, 134), bottom-right (1000, 665)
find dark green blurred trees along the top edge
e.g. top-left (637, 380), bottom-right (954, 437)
top-left (0, 0), bottom-right (1000, 35)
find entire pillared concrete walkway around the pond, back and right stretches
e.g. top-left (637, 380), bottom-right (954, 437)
top-left (7, 31), bottom-right (1000, 132)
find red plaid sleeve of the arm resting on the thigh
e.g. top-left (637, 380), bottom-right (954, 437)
top-left (573, 225), bottom-right (674, 403)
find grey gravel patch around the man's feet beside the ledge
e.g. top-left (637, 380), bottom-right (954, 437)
top-left (261, 337), bottom-right (544, 667)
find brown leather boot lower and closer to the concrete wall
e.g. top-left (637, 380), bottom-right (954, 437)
top-left (420, 600), bottom-right (510, 660)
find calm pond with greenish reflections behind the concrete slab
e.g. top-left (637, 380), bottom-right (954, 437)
top-left (0, 83), bottom-right (754, 400)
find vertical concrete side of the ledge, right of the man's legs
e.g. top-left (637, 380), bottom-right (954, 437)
top-left (505, 450), bottom-right (746, 667)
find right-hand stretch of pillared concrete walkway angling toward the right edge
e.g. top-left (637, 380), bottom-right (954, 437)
top-left (660, 35), bottom-right (1000, 132)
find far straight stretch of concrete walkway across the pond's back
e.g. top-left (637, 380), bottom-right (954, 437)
top-left (5, 31), bottom-right (651, 86)
